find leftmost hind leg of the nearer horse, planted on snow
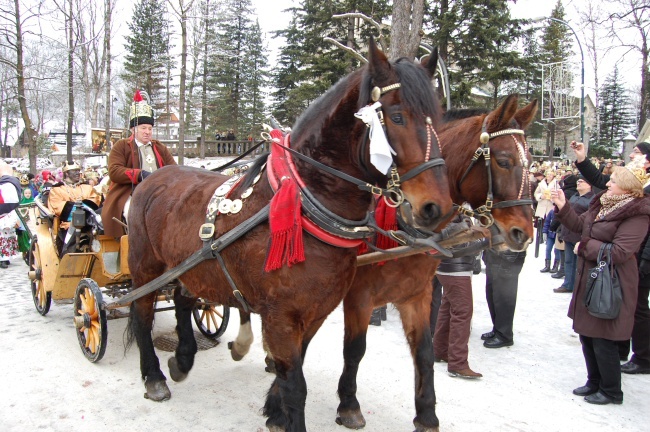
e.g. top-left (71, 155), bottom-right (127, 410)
top-left (129, 292), bottom-right (171, 402)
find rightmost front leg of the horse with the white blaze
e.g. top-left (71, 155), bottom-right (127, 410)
top-left (396, 294), bottom-right (440, 432)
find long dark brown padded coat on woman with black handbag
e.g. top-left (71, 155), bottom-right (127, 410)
top-left (556, 192), bottom-right (650, 340)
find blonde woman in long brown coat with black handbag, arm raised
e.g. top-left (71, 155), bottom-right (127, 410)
top-left (552, 161), bottom-right (650, 405)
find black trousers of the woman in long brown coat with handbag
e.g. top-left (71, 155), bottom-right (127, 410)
top-left (580, 335), bottom-right (623, 401)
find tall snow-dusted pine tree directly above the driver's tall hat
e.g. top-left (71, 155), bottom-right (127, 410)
top-left (123, 0), bottom-right (173, 102)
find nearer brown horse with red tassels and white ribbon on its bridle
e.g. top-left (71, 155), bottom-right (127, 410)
top-left (128, 41), bottom-right (453, 431)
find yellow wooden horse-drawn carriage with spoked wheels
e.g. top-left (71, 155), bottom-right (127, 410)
top-left (18, 199), bottom-right (230, 362)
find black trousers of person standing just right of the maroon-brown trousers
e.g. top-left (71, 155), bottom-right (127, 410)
top-left (483, 249), bottom-right (526, 341)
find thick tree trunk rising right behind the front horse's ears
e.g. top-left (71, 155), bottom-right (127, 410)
top-left (388, 0), bottom-right (424, 60)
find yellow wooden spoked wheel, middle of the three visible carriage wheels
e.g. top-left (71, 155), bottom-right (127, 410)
top-left (74, 279), bottom-right (108, 363)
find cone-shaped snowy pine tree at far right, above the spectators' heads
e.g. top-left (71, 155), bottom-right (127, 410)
top-left (589, 66), bottom-right (635, 157)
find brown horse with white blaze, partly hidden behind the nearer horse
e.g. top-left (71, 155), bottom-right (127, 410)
top-left (336, 96), bottom-right (537, 432)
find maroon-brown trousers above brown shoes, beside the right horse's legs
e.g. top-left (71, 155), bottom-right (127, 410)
top-left (433, 274), bottom-right (474, 371)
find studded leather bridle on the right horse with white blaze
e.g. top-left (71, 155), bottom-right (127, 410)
top-left (458, 116), bottom-right (533, 228)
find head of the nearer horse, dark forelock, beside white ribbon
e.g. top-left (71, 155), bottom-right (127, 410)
top-left (359, 39), bottom-right (453, 230)
